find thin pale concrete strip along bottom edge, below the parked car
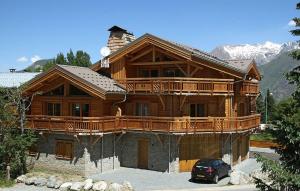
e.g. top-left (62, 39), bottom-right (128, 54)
top-left (153, 184), bottom-right (257, 191)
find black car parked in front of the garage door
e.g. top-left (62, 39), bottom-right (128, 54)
top-left (191, 159), bottom-right (231, 183)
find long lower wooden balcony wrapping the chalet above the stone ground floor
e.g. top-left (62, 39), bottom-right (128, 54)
top-left (27, 114), bottom-right (260, 134)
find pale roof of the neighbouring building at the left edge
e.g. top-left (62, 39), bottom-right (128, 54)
top-left (0, 72), bottom-right (39, 88)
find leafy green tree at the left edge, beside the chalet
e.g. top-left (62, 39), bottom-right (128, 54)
top-left (0, 88), bottom-right (36, 178)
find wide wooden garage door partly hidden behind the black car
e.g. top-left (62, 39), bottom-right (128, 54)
top-left (179, 135), bottom-right (220, 172)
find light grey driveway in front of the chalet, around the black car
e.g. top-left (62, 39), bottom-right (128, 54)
top-left (0, 148), bottom-right (276, 191)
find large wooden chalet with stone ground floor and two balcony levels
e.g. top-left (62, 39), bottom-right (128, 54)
top-left (24, 26), bottom-right (260, 175)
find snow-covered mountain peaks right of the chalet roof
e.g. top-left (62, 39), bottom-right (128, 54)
top-left (211, 41), bottom-right (299, 65)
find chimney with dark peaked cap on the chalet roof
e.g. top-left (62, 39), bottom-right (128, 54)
top-left (107, 26), bottom-right (135, 52)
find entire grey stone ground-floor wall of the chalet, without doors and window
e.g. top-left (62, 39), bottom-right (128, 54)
top-left (28, 132), bottom-right (248, 176)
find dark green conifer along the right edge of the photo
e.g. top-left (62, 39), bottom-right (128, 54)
top-left (255, 3), bottom-right (300, 191)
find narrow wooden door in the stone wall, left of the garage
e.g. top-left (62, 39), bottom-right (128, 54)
top-left (138, 139), bottom-right (149, 169)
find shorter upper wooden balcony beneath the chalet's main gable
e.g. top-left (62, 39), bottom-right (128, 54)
top-left (118, 77), bottom-right (233, 95)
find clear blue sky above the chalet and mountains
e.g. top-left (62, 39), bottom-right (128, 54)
top-left (0, 0), bottom-right (300, 72)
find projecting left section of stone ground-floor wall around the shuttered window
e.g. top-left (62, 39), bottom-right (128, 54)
top-left (27, 134), bottom-right (120, 176)
